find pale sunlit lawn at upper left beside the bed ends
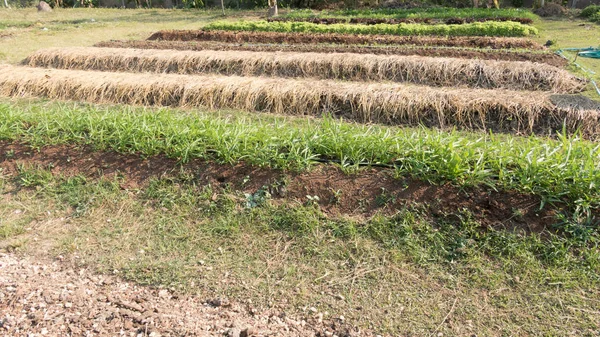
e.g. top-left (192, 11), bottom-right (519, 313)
top-left (0, 7), bottom-right (263, 63)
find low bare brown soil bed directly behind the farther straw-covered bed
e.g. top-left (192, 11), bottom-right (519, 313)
top-left (95, 40), bottom-right (568, 68)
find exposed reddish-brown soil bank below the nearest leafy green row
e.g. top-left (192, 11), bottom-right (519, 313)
top-left (0, 142), bottom-right (561, 232)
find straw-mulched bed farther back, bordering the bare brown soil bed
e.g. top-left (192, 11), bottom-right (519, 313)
top-left (25, 48), bottom-right (585, 93)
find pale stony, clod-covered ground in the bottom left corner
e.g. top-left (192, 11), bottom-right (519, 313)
top-left (0, 253), bottom-right (367, 337)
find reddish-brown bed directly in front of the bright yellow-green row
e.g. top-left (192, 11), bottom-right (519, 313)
top-left (148, 30), bottom-right (545, 50)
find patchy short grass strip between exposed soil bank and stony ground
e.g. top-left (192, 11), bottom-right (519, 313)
top-left (0, 167), bottom-right (600, 336)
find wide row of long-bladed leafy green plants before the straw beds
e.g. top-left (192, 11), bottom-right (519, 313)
top-left (0, 99), bottom-right (600, 209)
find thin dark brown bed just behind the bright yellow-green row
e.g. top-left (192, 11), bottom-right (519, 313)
top-left (267, 17), bottom-right (533, 25)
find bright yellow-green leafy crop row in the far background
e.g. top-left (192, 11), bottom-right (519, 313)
top-left (204, 21), bottom-right (537, 36)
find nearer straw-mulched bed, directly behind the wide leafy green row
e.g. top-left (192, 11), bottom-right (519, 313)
top-left (0, 66), bottom-right (600, 138)
